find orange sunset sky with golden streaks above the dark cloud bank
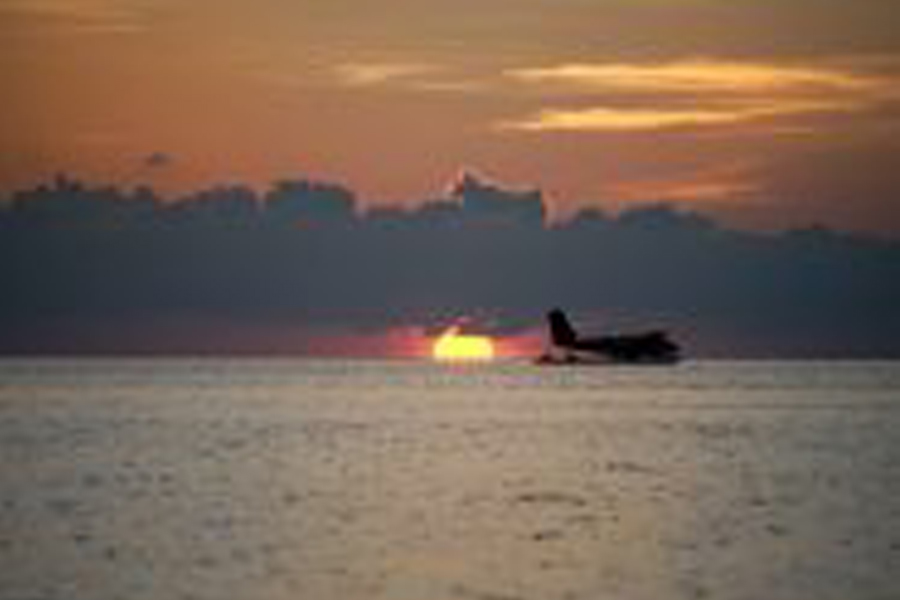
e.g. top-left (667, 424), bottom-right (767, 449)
top-left (0, 0), bottom-right (900, 235)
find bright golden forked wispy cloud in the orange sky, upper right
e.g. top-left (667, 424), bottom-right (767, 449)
top-left (495, 59), bottom-right (898, 132)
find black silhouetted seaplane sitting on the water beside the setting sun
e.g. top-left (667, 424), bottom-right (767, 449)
top-left (537, 308), bottom-right (681, 364)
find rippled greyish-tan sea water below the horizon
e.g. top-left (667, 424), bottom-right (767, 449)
top-left (0, 360), bottom-right (900, 600)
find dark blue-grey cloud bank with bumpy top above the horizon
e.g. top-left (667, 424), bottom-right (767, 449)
top-left (0, 171), bottom-right (900, 357)
